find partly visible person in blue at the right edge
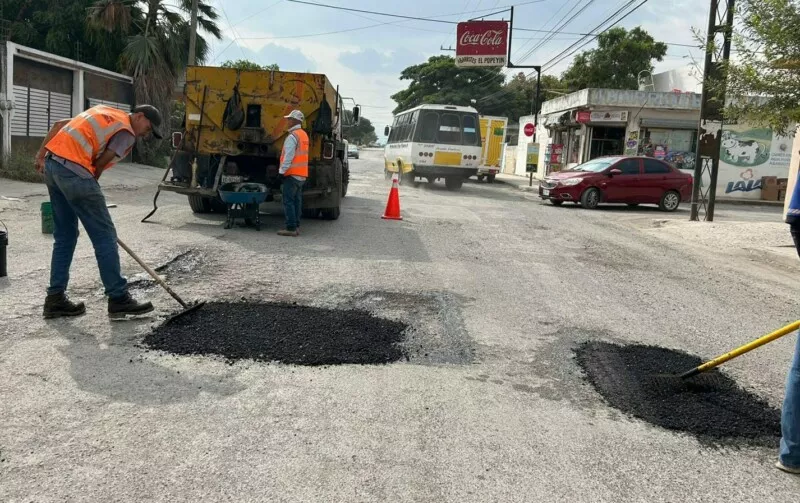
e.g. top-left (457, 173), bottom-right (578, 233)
top-left (776, 179), bottom-right (800, 475)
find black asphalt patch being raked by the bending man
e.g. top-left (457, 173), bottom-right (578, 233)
top-left (144, 302), bottom-right (407, 365)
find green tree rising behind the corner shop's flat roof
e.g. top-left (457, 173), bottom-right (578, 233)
top-left (561, 27), bottom-right (667, 91)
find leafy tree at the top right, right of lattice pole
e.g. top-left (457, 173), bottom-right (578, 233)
top-left (708, 0), bottom-right (800, 135)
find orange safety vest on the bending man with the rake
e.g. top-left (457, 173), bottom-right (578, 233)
top-left (45, 105), bottom-right (136, 176)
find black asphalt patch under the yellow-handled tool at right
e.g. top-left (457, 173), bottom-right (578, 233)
top-left (576, 341), bottom-right (781, 447)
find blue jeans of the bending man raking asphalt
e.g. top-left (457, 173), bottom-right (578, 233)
top-left (45, 158), bottom-right (128, 299)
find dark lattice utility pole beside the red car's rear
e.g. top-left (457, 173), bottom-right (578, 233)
top-left (690, 0), bottom-right (734, 222)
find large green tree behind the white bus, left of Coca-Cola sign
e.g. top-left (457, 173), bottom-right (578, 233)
top-left (392, 56), bottom-right (505, 113)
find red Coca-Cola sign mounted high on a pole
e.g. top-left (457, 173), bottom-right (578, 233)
top-left (456, 21), bottom-right (508, 66)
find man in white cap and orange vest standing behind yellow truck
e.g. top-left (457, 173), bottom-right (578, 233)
top-left (278, 110), bottom-right (309, 236)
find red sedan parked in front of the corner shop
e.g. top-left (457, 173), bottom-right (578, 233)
top-left (539, 156), bottom-right (692, 211)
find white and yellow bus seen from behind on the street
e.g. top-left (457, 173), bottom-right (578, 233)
top-left (383, 105), bottom-right (481, 190)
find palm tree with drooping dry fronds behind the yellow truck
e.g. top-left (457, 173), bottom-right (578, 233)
top-left (88, 0), bottom-right (222, 159)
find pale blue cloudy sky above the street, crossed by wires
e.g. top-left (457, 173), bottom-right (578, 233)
top-left (208, 0), bottom-right (709, 135)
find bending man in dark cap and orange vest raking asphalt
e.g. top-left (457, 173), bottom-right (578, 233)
top-left (36, 105), bottom-right (162, 318)
